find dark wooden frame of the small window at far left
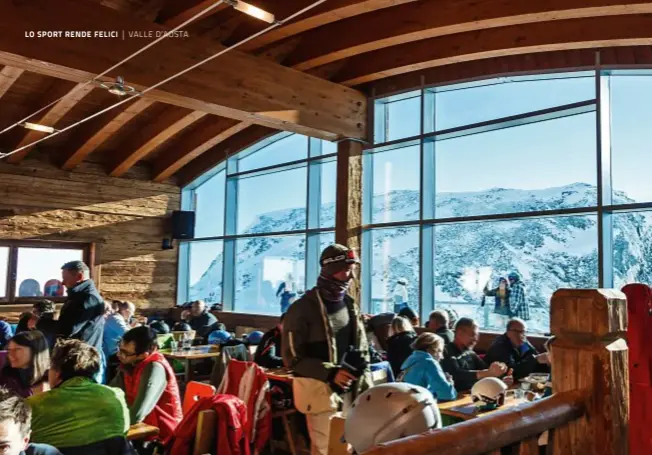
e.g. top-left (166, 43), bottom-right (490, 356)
top-left (0, 240), bottom-right (99, 305)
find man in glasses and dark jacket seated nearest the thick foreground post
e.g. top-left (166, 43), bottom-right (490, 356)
top-left (485, 318), bottom-right (548, 380)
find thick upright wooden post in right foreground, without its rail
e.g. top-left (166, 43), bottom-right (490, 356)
top-left (550, 289), bottom-right (629, 455)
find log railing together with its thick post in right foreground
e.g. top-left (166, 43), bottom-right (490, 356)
top-left (365, 289), bottom-right (629, 455)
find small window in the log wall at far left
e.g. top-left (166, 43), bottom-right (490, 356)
top-left (0, 240), bottom-right (91, 303)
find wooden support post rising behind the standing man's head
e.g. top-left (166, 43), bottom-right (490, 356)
top-left (335, 140), bottom-right (362, 302)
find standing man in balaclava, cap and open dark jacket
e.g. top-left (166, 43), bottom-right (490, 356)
top-left (282, 248), bottom-right (371, 455)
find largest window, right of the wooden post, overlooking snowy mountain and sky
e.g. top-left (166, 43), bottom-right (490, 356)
top-left (361, 71), bottom-right (652, 332)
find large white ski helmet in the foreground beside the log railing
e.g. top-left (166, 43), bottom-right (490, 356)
top-left (344, 382), bottom-right (441, 454)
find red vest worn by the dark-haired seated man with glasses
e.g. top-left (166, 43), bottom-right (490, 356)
top-left (122, 352), bottom-right (183, 443)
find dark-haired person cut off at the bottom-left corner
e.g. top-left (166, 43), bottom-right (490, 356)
top-left (0, 388), bottom-right (61, 455)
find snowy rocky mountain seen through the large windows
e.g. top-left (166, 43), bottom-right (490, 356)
top-left (190, 183), bottom-right (652, 330)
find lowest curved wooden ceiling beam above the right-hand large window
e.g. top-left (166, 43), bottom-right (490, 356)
top-left (332, 15), bottom-right (652, 86)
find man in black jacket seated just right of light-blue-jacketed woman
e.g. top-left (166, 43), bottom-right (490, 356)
top-left (441, 318), bottom-right (507, 391)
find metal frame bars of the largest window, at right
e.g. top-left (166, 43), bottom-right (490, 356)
top-left (361, 66), bottom-right (652, 330)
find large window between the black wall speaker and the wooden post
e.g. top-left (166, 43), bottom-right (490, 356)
top-left (178, 133), bottom-right (337, 315)
